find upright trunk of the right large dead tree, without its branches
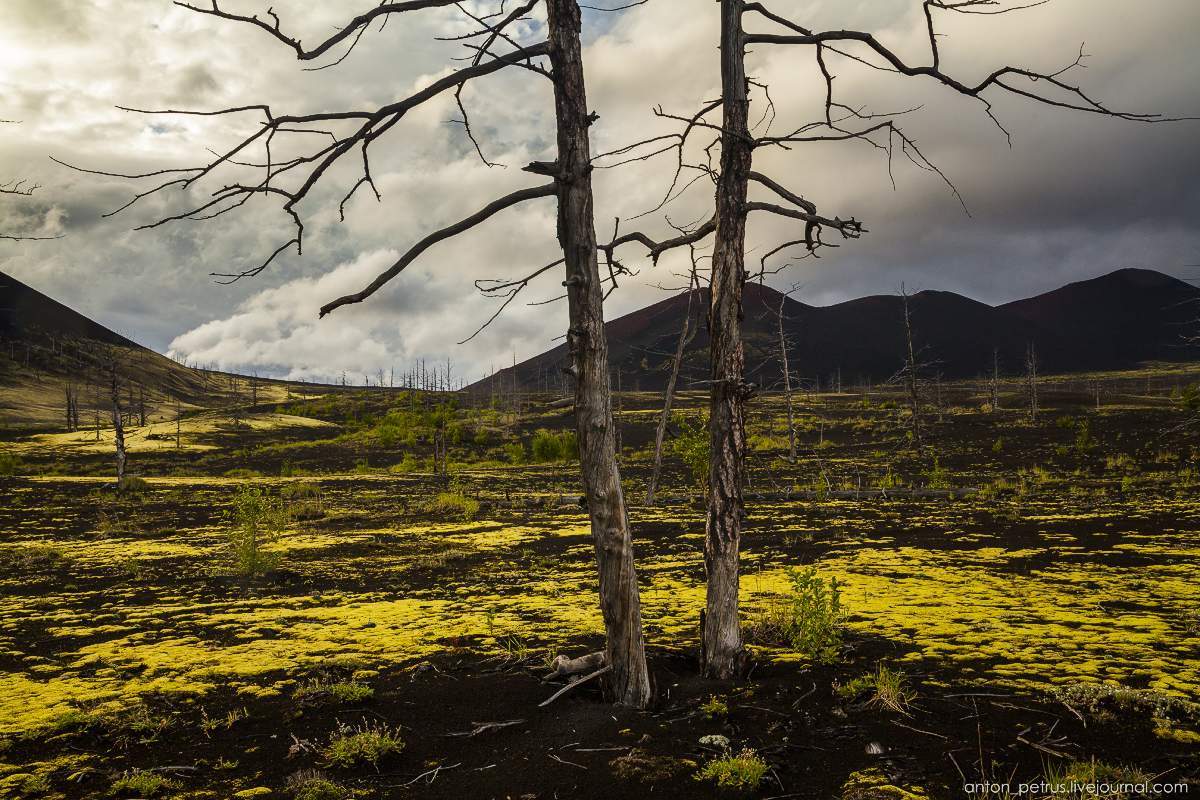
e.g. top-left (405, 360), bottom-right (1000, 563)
top-left (701, 0), bottom-right (754, 678)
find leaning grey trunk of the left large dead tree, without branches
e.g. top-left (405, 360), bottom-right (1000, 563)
top-left (549, 0), bottom-right (650, 708)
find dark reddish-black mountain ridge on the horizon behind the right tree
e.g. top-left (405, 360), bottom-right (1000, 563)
top-left (472, 269), bottom-right (1200, 391)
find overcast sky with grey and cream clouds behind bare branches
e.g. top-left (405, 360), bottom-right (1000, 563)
top-left (0, 0), bottom-right (1200, 378)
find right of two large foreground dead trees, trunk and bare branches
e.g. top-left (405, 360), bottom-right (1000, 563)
top-left (600, 0), bottom-right (1168, 678)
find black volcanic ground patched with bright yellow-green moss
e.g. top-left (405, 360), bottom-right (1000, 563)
top-left (0, 375), bottom-right (1200, 800)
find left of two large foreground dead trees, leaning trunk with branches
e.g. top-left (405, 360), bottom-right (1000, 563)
top-left (83, 0), bottom-right (650, 706)
